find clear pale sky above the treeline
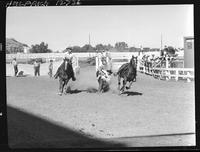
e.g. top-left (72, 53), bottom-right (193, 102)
top-left (6, 5), bottom-right (194, 51)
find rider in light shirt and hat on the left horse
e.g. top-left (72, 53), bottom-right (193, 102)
top-left (64, 48), bottom-right (76, 81)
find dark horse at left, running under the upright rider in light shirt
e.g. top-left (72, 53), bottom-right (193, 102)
top-left (54, 59), bottom-right (73, 95)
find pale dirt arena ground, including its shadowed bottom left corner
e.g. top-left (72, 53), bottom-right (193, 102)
top-left (6, 63), bottom-right (195, 148)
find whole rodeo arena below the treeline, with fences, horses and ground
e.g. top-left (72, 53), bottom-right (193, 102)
top-left (6, 37), bottom-right (196, 148)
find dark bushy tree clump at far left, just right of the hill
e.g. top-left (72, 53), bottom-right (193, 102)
top-left (30, 42), bottom-right (52, 53)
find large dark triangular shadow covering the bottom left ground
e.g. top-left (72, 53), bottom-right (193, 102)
top-left (7, 106), bottom-right (126, 148)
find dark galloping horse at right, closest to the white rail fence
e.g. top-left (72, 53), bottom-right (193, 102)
top-left (117, 56), bottom-right (137, 94)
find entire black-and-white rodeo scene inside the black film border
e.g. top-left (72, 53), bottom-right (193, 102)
top-left (5, 4), bottom-right (196, 149)
